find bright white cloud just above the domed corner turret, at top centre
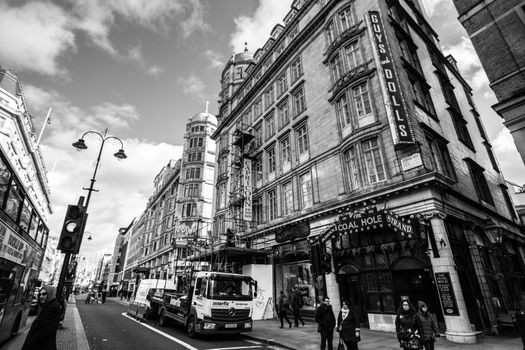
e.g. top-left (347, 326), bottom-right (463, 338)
top-left (230, 0), bottom-right (292, 52)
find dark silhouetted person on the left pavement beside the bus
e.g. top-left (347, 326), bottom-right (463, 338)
top-left (22, 285), bottom-right (61, 350)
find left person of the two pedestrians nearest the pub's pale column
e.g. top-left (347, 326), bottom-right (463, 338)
top-left (396, 299), bottom-right (423, 350)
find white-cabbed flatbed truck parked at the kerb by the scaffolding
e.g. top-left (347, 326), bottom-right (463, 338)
top-left (146, 271), bottom-right (257, 337)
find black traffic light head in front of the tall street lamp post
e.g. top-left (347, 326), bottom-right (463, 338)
top-left (58, 205), bottom-right (86, 254)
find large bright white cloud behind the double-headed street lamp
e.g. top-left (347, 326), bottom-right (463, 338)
top-left (24, 85), bottom-right (182, 259)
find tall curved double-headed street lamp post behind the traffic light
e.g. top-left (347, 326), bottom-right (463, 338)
top-left (57, 128), bottom-right (128, 298)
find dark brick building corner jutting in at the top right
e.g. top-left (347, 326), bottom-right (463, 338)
top-left (454, 0), bottom-right (525, 162)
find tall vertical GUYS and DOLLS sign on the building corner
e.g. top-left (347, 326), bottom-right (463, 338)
top-left (368, 11), bottom-right (415, 145)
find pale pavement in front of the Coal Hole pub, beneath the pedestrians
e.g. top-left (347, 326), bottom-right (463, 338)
top-left (247, 319), bottom-right (523, 350)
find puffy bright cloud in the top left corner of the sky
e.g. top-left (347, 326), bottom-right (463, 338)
top-left (0, 1), bottom-right (76, 76)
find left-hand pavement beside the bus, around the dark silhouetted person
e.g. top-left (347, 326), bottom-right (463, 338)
top-left (5, 295), bottom-right (89, 350)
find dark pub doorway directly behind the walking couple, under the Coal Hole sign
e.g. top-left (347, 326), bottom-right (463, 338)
top-left (338, 265), bottom-right (368, 326)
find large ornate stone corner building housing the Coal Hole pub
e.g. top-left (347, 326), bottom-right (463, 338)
top-left (212, 0), bottom-right (525, 343)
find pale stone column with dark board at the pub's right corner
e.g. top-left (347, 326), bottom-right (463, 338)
top-left (430, 214), bottom-right (477, 344)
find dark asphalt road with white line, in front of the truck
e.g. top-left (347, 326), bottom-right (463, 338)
top-left (77, 296), bottom-right (279, 350)
